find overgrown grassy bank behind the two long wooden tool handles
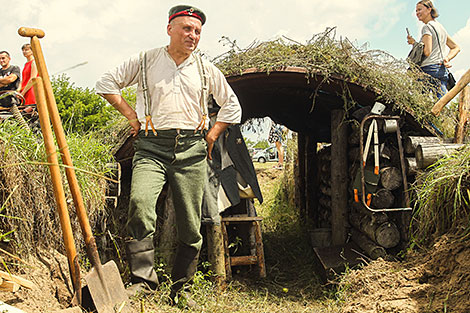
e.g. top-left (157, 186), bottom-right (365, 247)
top-left (0, 120), bottom-right (111, 256)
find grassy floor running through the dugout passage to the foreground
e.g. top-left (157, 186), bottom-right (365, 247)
top-left (130, 150), bottom-right (342, 313)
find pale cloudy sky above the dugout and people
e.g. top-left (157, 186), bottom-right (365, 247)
top-left (0, 0), bottom-right (470, 139)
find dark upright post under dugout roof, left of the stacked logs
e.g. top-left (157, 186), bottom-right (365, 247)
top-left (331, 110), bottom-right (348, 246)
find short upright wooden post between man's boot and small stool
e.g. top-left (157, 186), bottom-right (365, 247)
top-left (206, 224), bottom-right (226, 289)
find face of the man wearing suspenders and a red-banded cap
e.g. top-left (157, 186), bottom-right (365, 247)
top-left (167, 16), bottom-right (202, 53)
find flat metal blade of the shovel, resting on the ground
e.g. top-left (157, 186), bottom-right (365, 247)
top-left (83, 261), bottom-right (129, 313)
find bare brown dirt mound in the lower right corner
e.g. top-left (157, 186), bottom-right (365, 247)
top-left (341, 236), bottom-right (470, 313)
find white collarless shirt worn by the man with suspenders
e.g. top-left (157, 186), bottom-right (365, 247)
top-left (96, 47), bottom-right (241, 130)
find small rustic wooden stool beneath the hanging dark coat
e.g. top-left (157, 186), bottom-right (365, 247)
top-left (222, 216), bottom-right (266, 279)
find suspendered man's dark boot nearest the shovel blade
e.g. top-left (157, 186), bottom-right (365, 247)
top-left (126, 238), bottom-right (158, 295)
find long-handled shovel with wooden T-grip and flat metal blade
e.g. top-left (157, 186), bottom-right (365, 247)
top-left (18, 27), bottom-right (128, 313)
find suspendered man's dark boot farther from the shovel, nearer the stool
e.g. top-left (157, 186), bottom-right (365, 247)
top-left (170, 243), bottom-right (199, 308)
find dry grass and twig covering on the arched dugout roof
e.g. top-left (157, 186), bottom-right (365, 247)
top-left (213, 28), bottom-right (446, 124)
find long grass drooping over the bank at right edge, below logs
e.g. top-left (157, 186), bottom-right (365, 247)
top-left (413, 146), bottom-right (470, 240)
